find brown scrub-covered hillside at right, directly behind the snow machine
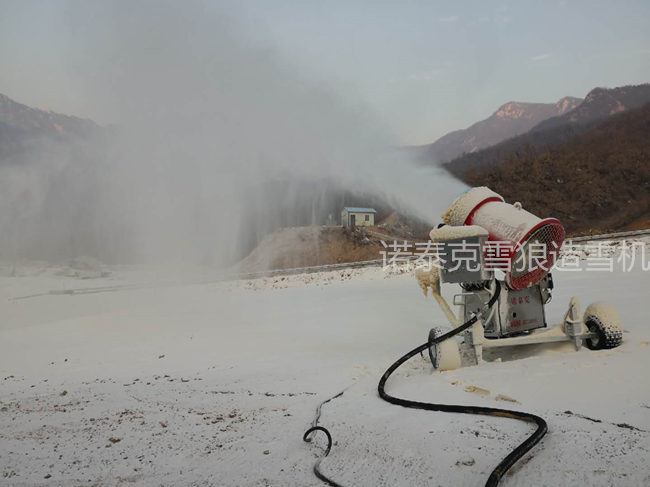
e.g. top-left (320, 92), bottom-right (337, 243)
top-left (461, 104), bottom-right (650, 232)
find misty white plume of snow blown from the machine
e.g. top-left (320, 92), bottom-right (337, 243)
top-left (0, 2), bottom-right (464, 265)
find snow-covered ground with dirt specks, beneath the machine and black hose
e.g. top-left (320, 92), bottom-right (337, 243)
top-left (0, 244), bottom-right (650, 487)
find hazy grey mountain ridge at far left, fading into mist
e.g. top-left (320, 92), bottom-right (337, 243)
top-left (0, 94), bottom-right (103, 162)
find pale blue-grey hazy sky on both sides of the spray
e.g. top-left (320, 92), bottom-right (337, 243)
top-left (0, 0), bottom-right (650, 144)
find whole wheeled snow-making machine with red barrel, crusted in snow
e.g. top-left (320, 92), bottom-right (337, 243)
top-left (416, 187), bottom-right (623, 370)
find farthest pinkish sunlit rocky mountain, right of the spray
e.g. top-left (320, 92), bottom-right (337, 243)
top-left (420, 96), bottom-right (582, 163)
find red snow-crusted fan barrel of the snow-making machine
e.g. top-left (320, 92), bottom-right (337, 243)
top-left (442, 186), bottom-right (565, 290)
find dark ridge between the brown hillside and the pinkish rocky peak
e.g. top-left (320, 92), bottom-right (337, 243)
top-left (445, 84), bottom-right (650, 176)
